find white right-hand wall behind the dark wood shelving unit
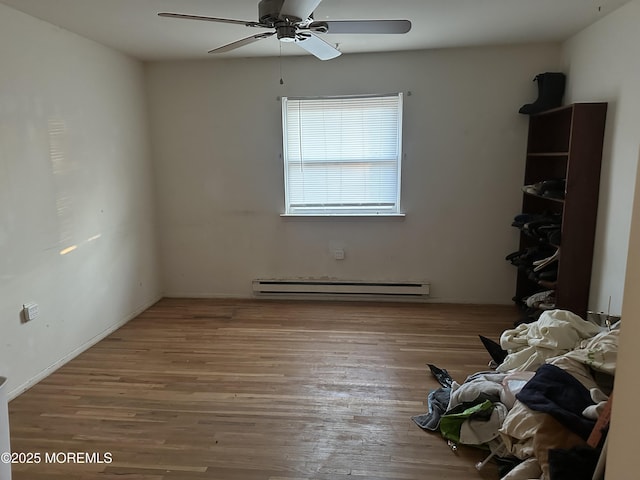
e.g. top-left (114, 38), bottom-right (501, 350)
top-left (564, 1), bottom-right (640, 315)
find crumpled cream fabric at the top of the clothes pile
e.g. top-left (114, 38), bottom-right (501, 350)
top-left (496, 309), bottom-right (600, 372)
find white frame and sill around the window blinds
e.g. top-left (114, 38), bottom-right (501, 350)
top-left (281, 92), bottom-right (405, 217)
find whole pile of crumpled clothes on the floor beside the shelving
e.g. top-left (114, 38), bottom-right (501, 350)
top-left (413, 310), bottom-right (619, 480)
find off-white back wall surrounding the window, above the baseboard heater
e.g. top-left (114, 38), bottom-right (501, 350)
top-left (148, 45), bottom-right (560, 303)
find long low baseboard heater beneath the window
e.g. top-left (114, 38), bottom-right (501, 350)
top-left (253, 279), bottom-right (430, 298)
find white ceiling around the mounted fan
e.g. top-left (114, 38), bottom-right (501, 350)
top-left (0, 0), bottom-right (629, 60)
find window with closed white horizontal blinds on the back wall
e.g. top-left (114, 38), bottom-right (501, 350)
top-left (282, 93), bottom-right (402, 215)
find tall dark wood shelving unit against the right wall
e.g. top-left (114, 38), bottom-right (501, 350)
top-left (516, 103), bottom-right (607, 318)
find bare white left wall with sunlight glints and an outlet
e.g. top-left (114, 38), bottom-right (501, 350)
top-left (0, 5), bottom-right (160, 397)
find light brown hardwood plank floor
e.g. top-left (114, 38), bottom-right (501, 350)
top-left (9, 299), bottom-right (517, 480)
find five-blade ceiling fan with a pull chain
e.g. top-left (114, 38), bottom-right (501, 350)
top-left (158, 0), bottom-right (411, 60)
